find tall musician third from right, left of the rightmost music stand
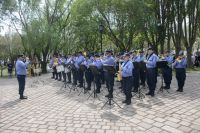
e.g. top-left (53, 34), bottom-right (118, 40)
top-left (145, 48), bottom-right (158, 97)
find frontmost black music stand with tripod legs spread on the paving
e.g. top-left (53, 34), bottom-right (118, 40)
top-left (101, 65), bottom-right (122, 109)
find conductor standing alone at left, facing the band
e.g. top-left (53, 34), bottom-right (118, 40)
top-left (16, 55), bottom-right (28, 100)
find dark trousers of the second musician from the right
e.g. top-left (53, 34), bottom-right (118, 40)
top-left (162, 67), bottom-right (172, 87)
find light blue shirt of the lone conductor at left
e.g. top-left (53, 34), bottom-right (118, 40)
top-left (16, 59), bottom-right (28, 75)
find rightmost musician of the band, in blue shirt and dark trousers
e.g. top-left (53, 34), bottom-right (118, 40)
top-left (173, 51), bottom-right (187, 92)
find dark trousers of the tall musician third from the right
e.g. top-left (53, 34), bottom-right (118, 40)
top-left (147, 68), bottom-right (157, 94)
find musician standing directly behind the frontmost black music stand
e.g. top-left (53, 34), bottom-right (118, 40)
top-left (102, 50), bottom-right (115, 98)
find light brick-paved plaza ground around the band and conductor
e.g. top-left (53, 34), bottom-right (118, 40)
top-left (0, 72), bottom-right (200, 133)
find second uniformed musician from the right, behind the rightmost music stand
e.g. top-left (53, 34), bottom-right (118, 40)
top-left (163, 51), bottom-right (174, 89)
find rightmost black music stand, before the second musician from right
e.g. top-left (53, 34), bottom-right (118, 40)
top-left (156, 61), bottom-right (169, 93)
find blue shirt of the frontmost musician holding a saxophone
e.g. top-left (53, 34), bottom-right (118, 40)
top-left (122, 61), bottom-right (134, 77)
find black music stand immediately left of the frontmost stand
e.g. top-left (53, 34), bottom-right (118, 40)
top-left (88, 65), bottom-right (100, 100)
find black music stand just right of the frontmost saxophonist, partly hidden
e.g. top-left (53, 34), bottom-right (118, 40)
top-left (133, 62), bottom-right (145, 99)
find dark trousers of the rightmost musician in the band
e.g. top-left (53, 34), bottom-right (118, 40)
top-left (176, 68), bottom-right (186, 90)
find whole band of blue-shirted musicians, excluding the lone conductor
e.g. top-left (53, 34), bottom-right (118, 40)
top-left (49, 48), bottom-right (187, 105)
